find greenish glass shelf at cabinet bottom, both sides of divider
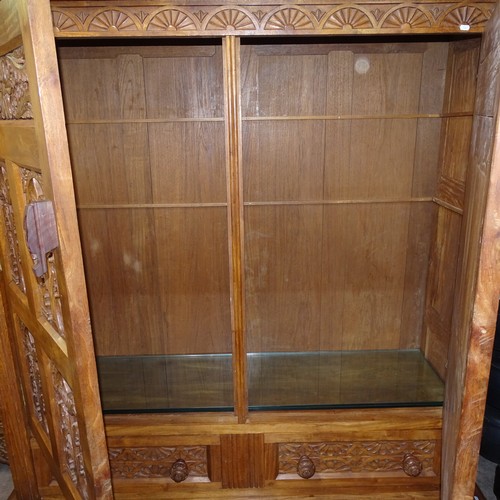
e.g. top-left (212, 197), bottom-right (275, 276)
top-left (97, 350), bottom-right (444, 413)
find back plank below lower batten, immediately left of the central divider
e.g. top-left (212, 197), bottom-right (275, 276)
top-left (154, 207), bottom-right (231, 354)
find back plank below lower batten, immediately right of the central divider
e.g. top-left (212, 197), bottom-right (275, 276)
top-left (245, 206), bottom-right (322, 352)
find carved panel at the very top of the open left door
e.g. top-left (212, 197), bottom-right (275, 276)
top-left (0, 47), bottom-right (33, 120)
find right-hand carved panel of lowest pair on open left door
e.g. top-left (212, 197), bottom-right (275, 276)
top-left (52, 367), bottom-right (89, 499)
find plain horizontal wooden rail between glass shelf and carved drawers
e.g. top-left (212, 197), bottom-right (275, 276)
top-left (101, 407), bottom-right (443, 444)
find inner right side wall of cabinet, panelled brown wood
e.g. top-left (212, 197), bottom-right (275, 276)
top-left (422, 40), bottom-right (479, 378)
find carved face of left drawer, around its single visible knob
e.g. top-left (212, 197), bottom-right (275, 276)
top-left (109, 446), bottom-right (208, 479)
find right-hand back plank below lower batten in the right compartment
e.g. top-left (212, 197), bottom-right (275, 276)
top-left (321, 204), bottom-right (409, 349)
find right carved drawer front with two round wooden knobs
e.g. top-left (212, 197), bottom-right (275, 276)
top-left (278, 441), bottom-right (439, 479)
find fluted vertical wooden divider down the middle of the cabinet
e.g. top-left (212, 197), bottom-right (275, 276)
top-left (222, 36), bottom-right (248, 423)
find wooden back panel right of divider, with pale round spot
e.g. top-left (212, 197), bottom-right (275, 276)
top-left (242, 43), bottom-right (447, 351)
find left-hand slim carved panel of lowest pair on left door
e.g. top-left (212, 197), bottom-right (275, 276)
top-left (19, 320), bottom-right (49, 434)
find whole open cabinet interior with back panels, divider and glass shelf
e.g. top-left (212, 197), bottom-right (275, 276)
top-left (58, 36), bottom-right (480, 412)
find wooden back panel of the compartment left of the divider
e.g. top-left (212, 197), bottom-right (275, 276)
top-left (60, 43), bottom-right (231, 355)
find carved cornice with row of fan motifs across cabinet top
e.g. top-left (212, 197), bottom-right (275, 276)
top-left (52, 0), bottom-right (495, 37)
